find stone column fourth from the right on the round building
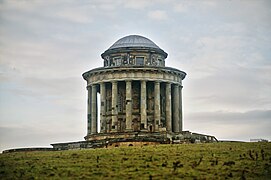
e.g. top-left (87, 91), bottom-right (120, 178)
top-left (154, 82), bottom-right (161, 131)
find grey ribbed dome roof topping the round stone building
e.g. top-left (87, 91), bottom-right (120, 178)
top-left (108, 35), bottom-right (163, 50)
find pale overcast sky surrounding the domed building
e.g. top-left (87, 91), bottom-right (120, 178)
top-left (0, 0), bottom-right (271, 151)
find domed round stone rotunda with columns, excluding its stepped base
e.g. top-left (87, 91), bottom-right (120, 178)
top-left (83, 35), bottom-right (186, 140)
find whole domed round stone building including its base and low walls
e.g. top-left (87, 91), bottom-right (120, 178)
top-left (4, 35), bottom-right (217, 152)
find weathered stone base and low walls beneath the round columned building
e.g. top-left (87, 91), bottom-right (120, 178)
top-left (51, 131), bottom-right (218, 150)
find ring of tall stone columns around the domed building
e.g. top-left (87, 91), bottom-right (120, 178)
top-left (87, 80), bottom-right (182, 134)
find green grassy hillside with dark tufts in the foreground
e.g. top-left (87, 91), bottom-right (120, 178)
top-left (0, 143), bottom-right (271, 179)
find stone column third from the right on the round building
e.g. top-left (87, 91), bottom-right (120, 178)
top-left (166, 83), bottom-right (172, 132)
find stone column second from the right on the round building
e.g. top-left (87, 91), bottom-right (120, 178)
top-left (173, 84), bottom-right (180, 132)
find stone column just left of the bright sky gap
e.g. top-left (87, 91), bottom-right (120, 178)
top-left (91, 84), bottom-right (97, 134)
